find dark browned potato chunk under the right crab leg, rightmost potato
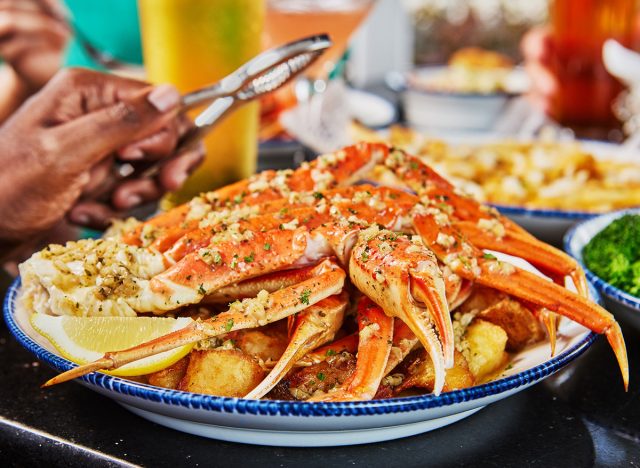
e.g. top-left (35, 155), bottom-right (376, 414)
top-left (477, 298), bottom-right (545, 351)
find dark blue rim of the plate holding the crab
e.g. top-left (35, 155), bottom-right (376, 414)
top-left (3, 277), bottom-right (600, 417)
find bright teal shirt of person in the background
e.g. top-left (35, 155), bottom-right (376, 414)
top-left (64, 0), bottom-right (142, 70)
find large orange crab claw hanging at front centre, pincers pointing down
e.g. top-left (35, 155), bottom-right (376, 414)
top-left (349, 229), bottom-right (454, 394)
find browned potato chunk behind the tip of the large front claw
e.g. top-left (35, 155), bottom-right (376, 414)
top-left (394, 349), bottom-right (475, 393)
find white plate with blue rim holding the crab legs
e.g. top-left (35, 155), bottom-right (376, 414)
top-left (4, 272), bottom-right (597, 447)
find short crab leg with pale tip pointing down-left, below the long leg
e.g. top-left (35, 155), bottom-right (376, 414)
top-left (245, 293), bottom-right (349, 399)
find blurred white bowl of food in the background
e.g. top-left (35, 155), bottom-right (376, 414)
top-left (402, 66), bottom-right (524, 131)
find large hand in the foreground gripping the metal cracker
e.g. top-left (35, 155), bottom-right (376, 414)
top-left (0, 69), bottom-right (202, 241)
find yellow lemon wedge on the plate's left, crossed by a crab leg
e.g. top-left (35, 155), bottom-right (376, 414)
top-left (30, 313), bottom-right (193, 377)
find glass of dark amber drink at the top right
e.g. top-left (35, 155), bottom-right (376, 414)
top-left (550, 0), bottom-right (637, 129)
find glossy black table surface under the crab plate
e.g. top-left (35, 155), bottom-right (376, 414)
top-left (0, 144), bottom-right (640, 468)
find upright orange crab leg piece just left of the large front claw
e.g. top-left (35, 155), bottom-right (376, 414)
top-left (308, 297), bottom-right (393, 401)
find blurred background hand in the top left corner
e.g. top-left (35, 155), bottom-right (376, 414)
top-left (0, 0), bottom-right (70, 93)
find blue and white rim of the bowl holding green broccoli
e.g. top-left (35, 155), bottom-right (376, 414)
top-left (564, 208), bottom-right (640, 311)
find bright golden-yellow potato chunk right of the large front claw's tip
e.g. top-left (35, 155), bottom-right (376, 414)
top-left (461, 319), bottom-right (508, 382)
